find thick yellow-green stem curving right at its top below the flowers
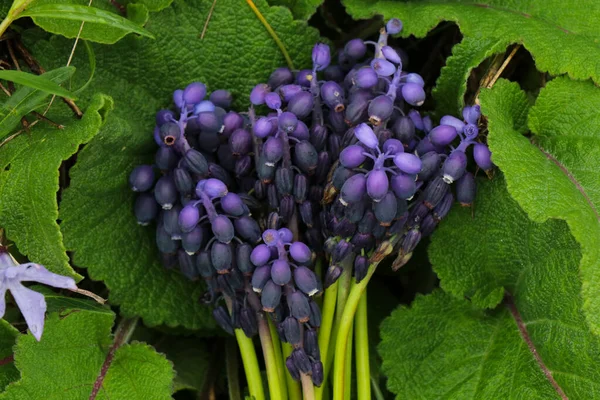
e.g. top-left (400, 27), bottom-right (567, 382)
top-left (333, 262), bottom-right (379, 400)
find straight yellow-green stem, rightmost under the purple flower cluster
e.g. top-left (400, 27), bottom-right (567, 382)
top-left (354, 291), bottom-right (371, 400)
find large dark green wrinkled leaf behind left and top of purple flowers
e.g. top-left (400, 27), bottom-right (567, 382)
top-left (24, 0), bottom-right (318, 329)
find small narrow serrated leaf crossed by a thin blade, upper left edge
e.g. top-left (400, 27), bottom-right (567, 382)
top-left (0, 67), bottom-right (75, 139)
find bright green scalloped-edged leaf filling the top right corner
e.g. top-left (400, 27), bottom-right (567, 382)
top-left (344, 0), bottom-right (600, 119)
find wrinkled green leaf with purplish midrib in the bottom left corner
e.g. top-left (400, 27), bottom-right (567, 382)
top-left (0, 310), bottom-right (174, 400)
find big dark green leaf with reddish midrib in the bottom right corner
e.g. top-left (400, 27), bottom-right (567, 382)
top-left (379, 177), bottom-right (600, 399)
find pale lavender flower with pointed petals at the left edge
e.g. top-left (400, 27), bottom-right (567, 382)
top-left (0, 246), bottom-right (77, 341)
